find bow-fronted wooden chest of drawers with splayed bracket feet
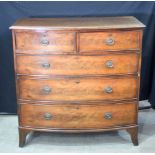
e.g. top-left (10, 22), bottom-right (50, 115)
top-left (11, 16), bottom-right (144, 147)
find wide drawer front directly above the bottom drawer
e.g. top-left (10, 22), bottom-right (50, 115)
top-left (18, 77), bottom-right (137, 101)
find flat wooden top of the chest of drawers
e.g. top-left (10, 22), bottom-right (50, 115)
top-left (10, 16), bottom-right (145, 30)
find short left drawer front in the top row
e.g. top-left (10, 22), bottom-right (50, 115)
top-left (16, 31), bottom-right (75, 54)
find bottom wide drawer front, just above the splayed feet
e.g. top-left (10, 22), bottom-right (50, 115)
top-left (20, 102), bottom-right (137, 129)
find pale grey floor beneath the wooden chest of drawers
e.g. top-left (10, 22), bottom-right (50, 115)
top-left (0, 101), bottom-right (155, 153)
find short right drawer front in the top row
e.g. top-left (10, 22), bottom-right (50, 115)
top-left (80, 31), bottom-right (140, 52)
